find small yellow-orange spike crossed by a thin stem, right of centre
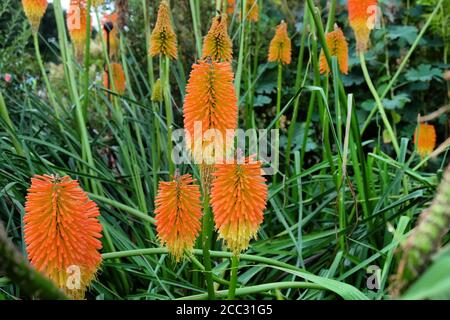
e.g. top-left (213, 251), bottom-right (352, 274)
top-left (320, 28), bottom-right (348, 74)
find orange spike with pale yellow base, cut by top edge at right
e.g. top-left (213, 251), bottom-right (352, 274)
top-left (348, 0), bottom-right (378, 52)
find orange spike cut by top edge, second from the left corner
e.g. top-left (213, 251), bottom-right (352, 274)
top-left (67, 0), bottom-right (92, 58)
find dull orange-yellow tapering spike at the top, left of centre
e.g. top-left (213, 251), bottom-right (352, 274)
top-left (150, 1), bottom-right (178, 59)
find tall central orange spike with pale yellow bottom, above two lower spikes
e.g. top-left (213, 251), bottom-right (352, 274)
top-left (184, 59), bottom-right (238, 164)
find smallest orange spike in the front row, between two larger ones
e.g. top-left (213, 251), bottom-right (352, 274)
top-left (155, 174), bottom-right (202, 262)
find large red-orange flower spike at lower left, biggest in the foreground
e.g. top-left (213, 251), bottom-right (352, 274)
top-left (23, 175), bottom-right (102, 299)
